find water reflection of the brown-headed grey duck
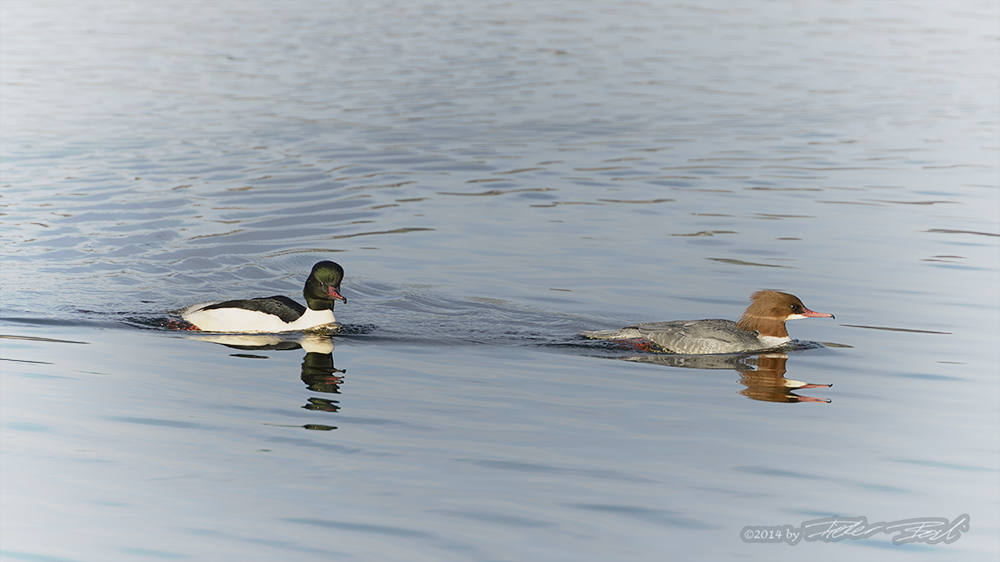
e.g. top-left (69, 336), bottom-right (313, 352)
top-left (623, 353), bottom-right (833, 403)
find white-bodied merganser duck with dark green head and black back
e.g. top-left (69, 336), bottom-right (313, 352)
top-left (181, 261), bottom-right (347, 332)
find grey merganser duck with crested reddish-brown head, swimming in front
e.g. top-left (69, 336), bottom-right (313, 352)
top-left (581, 291), bottom-right (834, 354)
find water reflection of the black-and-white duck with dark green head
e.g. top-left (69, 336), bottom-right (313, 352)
top-left (191, 334), bottom-right (347, 412)
